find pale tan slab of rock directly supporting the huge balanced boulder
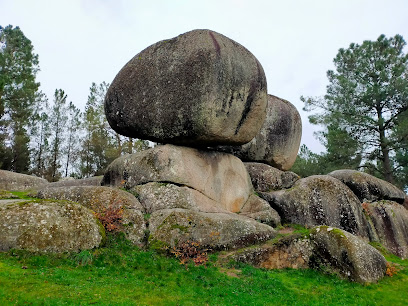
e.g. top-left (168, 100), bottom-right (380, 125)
top-left (102, 145), bottom-right (252, 212)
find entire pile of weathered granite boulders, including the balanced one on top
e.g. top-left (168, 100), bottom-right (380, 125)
top-left (0, 30), bottom-right (408, 283)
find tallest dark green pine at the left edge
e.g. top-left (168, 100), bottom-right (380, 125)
top-left (0, 25), bottom-right (40, 172)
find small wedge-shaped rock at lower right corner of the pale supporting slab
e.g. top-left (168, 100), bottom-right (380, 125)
top-left (241, 194), bottom-right (281, 227)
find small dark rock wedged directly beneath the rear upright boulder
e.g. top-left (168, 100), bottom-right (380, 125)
top-left (244, 162), bottom-right (300, 192)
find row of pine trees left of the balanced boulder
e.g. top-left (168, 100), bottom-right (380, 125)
top-left (0, 26), bottom-right (148, 181)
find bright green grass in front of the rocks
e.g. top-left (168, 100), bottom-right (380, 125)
top-left (0, 235), bottom-right (408, 305)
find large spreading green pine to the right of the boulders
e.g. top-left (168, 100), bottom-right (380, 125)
top-left (301, 35), bottom-right (408, 185)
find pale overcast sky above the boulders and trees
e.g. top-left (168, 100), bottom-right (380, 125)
top-left (0, 0), bottom-right (408, 152)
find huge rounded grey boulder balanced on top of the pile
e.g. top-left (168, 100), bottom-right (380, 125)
top-left (105, 30), bottom-right (267, 146)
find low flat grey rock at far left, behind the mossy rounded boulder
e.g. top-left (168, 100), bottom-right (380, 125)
top-left (0, 170), bottom-right (48, 191)
